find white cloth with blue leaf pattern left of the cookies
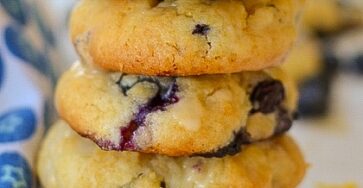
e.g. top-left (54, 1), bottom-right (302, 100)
top-left (0, 0), bottom-right (59, 188)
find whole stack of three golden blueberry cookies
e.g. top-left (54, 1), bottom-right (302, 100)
top-left (38, 0), bottom-right (306, 187)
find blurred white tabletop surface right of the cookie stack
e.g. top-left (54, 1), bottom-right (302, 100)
top-left (290, 73), bottom-right (363, 188)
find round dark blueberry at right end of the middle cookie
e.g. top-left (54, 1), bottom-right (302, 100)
top-left (250, 80), bottom-right (285, 113)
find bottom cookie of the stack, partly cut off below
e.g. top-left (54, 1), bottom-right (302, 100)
top-left (37, 121), bottom-right (307, 188)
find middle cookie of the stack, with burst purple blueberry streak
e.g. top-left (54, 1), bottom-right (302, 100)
top-left (55, 63), bottom-right (297, 156)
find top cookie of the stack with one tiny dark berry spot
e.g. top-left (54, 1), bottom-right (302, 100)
top-left (70, 0), bottom-right (301, 76)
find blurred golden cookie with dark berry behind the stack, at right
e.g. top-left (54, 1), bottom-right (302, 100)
top-left (282, 37), bottom-right (338, 117)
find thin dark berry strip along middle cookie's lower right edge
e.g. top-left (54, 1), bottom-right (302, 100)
top-left (197, 128), bottom-right (250, 158)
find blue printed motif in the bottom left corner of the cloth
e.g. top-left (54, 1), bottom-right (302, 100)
top-left (0, 152), bottom-right (32, 188)
